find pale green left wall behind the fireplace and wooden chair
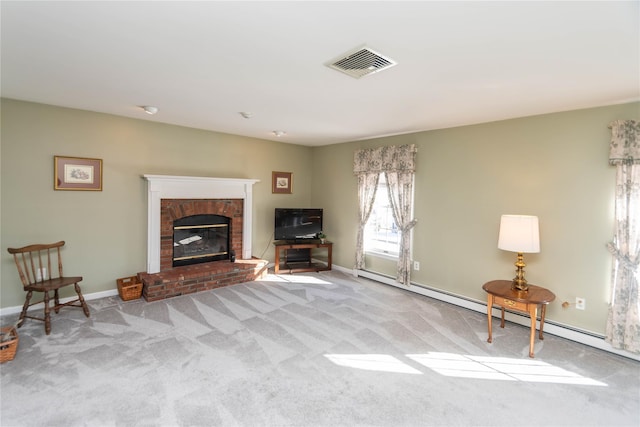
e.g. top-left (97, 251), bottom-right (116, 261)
top-left (0, 99), bottom-right (314, 307)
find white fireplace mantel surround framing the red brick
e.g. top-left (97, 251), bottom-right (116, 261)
top-left (143, 175), bottom-right (260, 274)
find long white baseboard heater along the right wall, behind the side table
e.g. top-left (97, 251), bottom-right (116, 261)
top-left (344, 266), bottom-right (640, 361)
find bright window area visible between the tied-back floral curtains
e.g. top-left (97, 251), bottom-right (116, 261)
top-left (364, 173), bottom-right (400, 257)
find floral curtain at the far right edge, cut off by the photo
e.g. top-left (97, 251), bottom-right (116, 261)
top-left (605, 120), bottom-right (640, 353)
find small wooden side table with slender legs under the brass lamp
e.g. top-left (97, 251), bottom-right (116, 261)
top-left (482, 280), bottom-right (556, 357)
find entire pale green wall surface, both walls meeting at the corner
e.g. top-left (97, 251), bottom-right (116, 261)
top-left (0, 99), bottom-right (640, 334)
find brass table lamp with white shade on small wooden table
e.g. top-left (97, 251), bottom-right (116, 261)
top-left (498, 215), bottom-right (540, 292)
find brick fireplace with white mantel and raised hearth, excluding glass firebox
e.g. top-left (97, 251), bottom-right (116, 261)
top-left (138, 175), bottom-right (267, 301)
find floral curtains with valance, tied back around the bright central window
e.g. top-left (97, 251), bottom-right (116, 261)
top-left (353, 144), bottom-right (417, 285)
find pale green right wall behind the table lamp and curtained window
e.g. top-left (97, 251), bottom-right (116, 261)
top-left (311, 103), bottom-right (640, 334)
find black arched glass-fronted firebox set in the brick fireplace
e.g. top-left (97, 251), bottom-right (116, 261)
top-left (173, 215), bottom-right (231, 267)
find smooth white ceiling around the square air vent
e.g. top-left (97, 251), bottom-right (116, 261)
top-left (0, 0), bottom-right (640, 145)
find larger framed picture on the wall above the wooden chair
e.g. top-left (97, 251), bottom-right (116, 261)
top-left (53, 156), bottom-right (102, 191)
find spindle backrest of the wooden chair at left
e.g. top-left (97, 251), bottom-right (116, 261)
top-left (7, 240), bottom-right (64, 286)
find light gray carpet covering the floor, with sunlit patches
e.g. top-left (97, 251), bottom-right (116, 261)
top-left (0, 271), bottom-right (640, 427)
